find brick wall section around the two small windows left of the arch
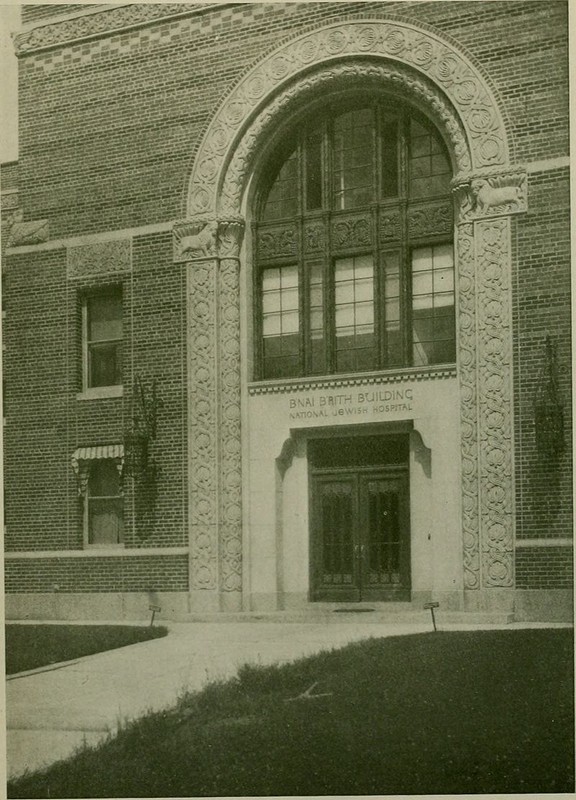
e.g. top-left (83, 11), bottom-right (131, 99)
top-left (4, 234), bottom-right (186, 551)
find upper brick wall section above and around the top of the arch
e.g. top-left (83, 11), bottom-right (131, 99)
top-left (15, 0), bottom-right (568, 236)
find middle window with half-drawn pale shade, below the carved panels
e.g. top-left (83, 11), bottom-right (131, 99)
top-left (334, 255), bottom-right (376, 372)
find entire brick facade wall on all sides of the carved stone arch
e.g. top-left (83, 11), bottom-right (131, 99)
top-left (2, 0), bottom-right (572, 591)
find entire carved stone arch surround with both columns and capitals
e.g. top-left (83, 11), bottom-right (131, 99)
top-left (174, 17), bottom-right (527, 611)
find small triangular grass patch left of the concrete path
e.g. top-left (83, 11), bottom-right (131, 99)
top-left (5, 625), bottom-right (168, 675)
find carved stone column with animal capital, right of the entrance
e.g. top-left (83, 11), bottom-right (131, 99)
top-left (455, 169), bottom-right (526, 611)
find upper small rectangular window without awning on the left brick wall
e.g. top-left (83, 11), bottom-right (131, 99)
top-left (83, 288), bottom-right (123, 389)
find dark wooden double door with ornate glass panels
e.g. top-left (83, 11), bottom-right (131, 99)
top-left (311, 467), bottom-right (410, 602)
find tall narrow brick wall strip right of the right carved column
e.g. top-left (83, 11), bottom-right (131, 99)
top-left (513, 169), bottom-right (572, 552)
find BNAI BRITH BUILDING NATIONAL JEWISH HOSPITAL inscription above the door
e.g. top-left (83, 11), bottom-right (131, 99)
top-left (289, 388), bottom-right (413, 419)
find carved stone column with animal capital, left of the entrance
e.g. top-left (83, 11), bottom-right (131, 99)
top-left (174, 219), bottom-right (244, 612)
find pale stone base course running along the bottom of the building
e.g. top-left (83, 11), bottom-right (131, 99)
top-left (5, 589), bottom-right (574, 624)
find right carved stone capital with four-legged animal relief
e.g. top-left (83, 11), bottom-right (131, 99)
top-left (452, 167), bottom-right (528, 223)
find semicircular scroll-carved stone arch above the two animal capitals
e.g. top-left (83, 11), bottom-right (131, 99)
top-left (188, 19), bottom-right (508, 214)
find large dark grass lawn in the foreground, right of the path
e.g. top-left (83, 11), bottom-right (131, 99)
top-left (8, 627), bottom-right (574, 798)
